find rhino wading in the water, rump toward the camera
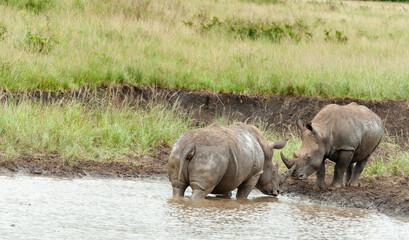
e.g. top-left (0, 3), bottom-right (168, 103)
top-left (168, 123), bottom-right (294, 198)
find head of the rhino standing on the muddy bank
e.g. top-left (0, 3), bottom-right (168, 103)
top-left (281, 119), bottom-right (325, 180)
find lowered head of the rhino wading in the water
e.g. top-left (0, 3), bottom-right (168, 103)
top-left (256, 140), bottom-right (295, 196)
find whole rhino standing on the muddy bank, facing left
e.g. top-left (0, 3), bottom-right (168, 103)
top-left (281, 103), bottom-right (383, 189)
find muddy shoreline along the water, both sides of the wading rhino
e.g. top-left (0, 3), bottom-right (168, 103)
top-left (0, 154), bottom-right (409, 218)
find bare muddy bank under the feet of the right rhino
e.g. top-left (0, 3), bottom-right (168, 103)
top-left (285, 174), bottom-right (409, 218)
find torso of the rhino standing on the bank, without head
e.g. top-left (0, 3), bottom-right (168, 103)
top-left (312, 103), bottom-right (383, 161)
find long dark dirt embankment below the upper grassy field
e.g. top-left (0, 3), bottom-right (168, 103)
top-left (0, 85), bottom-right (409, 143)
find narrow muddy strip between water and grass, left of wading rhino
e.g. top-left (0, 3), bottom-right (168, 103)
top-left (0, 146), bottom-right (171, 178)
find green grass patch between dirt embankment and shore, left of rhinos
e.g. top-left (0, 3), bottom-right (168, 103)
top-left (0, 98), bottom-right (190, 161)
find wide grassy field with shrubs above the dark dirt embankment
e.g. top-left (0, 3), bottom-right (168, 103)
top-left (0, 0), bottom-right (409, 99)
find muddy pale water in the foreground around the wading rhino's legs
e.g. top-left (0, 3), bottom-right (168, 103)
top-left (0, 175), bottom-right (409, 239)
